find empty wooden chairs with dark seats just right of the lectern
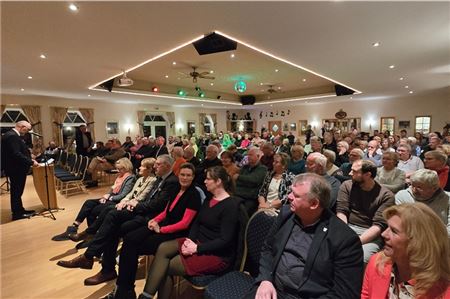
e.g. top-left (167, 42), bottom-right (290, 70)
top-left (55, 151), bottom-right (89, 197)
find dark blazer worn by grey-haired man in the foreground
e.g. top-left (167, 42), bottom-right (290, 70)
top-left (255, 205), bottom-right (363, 299)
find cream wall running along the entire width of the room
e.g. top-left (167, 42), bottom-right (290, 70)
top-left (1, 89), bottom-right (450, 143)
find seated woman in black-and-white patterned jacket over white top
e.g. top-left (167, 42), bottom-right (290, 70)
top-left (258, 153), bottom-right (294, 210)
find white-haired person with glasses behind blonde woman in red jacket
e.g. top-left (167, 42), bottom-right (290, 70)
top-left (395, 169), bottom-right (450, 237)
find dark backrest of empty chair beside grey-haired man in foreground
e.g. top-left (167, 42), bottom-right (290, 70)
top-left (241, 209), bottom-right (278, 277)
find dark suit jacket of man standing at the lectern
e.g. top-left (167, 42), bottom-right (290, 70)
top-left (2, 130), bottom-right (33, 176)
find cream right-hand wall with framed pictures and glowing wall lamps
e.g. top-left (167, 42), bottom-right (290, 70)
top-left (230, 90), bottom-right (450, 134)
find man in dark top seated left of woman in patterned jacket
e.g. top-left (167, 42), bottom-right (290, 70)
top-left (233, 147), bottom-right (273, 217)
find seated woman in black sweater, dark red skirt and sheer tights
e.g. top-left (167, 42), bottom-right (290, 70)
top-left (139, 166), bottom-right (239, 299)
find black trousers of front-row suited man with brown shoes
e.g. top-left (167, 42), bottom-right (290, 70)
top-left (84, 209), bottom-right (147, 264)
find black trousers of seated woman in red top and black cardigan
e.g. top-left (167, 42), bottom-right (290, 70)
top-left (116, 223), bottom-right (186, 290)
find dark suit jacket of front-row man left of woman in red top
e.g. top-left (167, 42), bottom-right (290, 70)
top-left (135, 172), bottom-right (180, 219)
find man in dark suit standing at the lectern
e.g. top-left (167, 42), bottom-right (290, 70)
top-left (2, 121), bottom-right (38, 220)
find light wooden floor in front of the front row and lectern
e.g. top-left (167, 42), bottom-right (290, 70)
top-left (0, 176), bottom-right (202, 299)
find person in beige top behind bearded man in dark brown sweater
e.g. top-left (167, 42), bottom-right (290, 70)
top-left (375, 152), bottom-right (406, 193)
